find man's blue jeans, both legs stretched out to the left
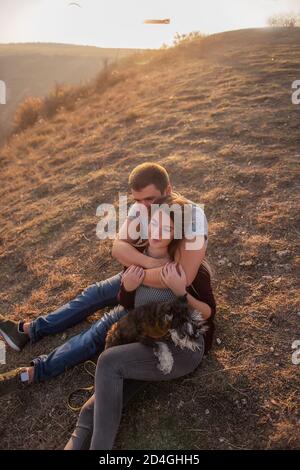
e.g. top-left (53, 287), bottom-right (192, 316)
top-left (29, 273), bottom-right (127, 382)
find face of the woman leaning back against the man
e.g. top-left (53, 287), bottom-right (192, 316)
top-left (148, 210), bottom-right (174, 248)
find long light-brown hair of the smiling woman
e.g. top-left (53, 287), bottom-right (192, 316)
top-left (149, 192), bottom-right (213, 277)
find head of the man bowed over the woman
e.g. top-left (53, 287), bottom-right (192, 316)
top-left (128, 163), bottom-right (172, 207)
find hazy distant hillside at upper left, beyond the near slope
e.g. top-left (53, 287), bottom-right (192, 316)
top-left (0, 43), bottom-right (146, 138)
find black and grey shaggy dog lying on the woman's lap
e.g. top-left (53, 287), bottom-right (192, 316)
top-left (105, 299), bottom-right (208, 374)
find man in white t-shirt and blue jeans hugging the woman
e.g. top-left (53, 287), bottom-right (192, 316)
top-left (0, 163), bottom-right (207, 396)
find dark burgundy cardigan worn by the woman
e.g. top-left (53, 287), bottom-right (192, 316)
top-left (118, 265), bottom-right (216, 354)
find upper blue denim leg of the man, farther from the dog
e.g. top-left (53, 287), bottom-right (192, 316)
top-left (29, 273), bottom-right (122, 343)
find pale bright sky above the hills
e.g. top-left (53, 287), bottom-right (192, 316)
top-left (0, 0), bottom-right (300, 48)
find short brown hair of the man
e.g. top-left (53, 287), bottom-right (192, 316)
top-left (128, 162), bottom-right (170, 194)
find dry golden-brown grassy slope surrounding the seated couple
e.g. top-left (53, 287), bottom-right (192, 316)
top-left (0, 29), bottom-right (300, 450)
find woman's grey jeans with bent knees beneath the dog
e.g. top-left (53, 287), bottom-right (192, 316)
top-left (65, 337), bottom-right (204, 450)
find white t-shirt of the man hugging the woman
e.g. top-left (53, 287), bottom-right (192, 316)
top-left (127, 200), bottom-right (208, 247)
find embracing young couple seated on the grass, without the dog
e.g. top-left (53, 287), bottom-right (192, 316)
top-left (0, 163), bottom-right (216, 450)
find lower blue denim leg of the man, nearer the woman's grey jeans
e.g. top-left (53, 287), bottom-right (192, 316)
top-left (31, 305), bottom-right (128, 382)
